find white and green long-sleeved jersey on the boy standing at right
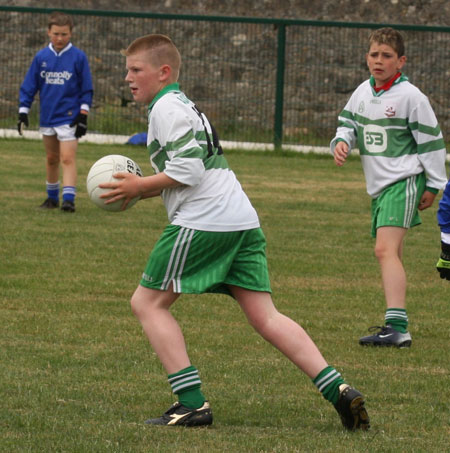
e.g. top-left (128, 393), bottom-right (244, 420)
top-left (330, 75), bottom-right (447, 198)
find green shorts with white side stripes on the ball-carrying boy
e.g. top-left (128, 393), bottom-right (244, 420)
top-left (141, 225), bottom-right (271, 295)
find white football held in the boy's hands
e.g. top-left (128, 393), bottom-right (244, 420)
top-left (86, 154), bottom-right (142, 212)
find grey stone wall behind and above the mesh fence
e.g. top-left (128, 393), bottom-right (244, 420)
top-left (0, 0), bottom-right (450, 144)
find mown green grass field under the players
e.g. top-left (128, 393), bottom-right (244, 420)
top-left (0, 140), bottom-right (450, 453)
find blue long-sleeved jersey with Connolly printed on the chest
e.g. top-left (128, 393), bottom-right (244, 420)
top-left (19, 43), bottom-right (94, 127)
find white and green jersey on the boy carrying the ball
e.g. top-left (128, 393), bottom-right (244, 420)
top-left (147, 83), bottom-right (259, 231)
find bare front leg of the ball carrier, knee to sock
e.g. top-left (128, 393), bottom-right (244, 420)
top-left (131, 285), bottom-right (191, 374)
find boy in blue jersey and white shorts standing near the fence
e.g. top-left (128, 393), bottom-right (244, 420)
top-left (17, 12), bottom-right (93, 212)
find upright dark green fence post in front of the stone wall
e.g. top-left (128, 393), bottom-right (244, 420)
top-left (274, 24), bottom-right (286, 151)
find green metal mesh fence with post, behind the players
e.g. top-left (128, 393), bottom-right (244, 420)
top-left (0, 6), bottom-right (450, 147)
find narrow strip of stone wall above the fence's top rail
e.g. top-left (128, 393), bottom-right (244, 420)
top-left (0, 0), bottom-right (450, 26)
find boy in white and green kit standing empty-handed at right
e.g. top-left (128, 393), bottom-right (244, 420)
top-left (330, 28), bottom-right (446, 347)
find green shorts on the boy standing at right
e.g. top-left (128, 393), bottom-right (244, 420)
top-left (372, 173), bottom-right (426, 237)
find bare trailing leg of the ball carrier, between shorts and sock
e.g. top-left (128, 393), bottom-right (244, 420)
top-left (230, 286), bottom-right (327, 379)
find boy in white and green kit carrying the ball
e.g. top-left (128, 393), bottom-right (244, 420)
top-left (102, 35), bottom-right (369, 430)
